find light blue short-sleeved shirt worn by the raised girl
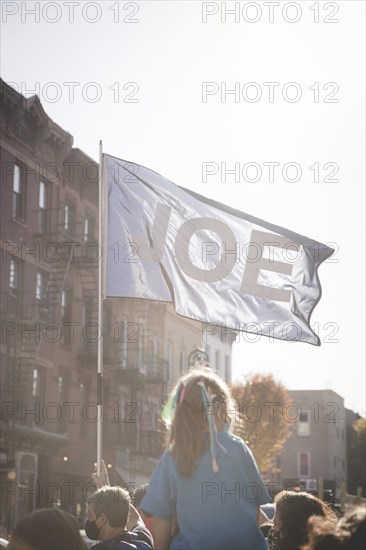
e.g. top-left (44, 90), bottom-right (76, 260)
top-left (140, 432), bottom-right (269, 550)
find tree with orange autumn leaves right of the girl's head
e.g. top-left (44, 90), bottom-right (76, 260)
top-left (231, 374), bottom-right (293, 473)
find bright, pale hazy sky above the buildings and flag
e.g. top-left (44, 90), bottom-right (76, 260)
top-left (1, 0), bottom-right (365, 414)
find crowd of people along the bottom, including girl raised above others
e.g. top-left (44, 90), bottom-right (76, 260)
top-left (2, 369), bottom-right (366, 550)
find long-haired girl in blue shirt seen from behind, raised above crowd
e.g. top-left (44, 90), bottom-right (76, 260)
top-left (141, 369), bottom-right (269, 550)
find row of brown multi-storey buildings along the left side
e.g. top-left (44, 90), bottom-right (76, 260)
top-left (0, 81), bottom-right (232, 533)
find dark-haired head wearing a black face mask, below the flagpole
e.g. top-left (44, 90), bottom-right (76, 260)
top-left (85, 486), bottom-right (131, 541)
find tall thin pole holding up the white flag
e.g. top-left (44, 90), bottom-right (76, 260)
top-left (97, 140), bottom-right (105, 476)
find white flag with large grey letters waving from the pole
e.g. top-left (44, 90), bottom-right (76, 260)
top-left (104, 155), bottom-right (333, 345)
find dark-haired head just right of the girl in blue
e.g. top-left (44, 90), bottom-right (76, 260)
top-left (268, 491), bottom-right (336, 550)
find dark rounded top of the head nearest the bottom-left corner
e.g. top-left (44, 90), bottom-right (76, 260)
top-left (7, 508), bottom-right (87, 550)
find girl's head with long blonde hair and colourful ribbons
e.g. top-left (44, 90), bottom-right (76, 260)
top-left (167, 368), bottom-right (235, 476)
